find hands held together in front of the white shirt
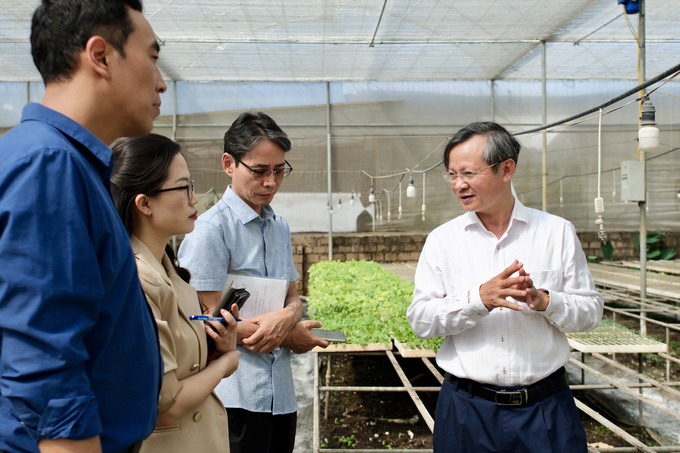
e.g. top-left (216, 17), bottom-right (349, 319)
top-left (479, 260), bottom-right (550, 311)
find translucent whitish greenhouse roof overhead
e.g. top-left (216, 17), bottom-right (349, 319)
top-left (0, 0), bottom-right (680, 81)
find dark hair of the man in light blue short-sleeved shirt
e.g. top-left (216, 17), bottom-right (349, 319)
top-left (224, 112), bottom-right (291, 162)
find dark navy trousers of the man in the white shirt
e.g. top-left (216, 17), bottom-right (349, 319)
top-left (434, 381), bottom-right (588, 453)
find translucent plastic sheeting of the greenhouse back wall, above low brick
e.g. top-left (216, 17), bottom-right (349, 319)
top-left (141, 81), bottom-right (680, 231)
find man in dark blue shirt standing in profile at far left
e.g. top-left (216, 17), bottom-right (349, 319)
top-left (0, 0), bottom-right (166, 453)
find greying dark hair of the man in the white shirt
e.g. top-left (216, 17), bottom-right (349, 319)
top-left (444, 121), bottom-right (521, 173)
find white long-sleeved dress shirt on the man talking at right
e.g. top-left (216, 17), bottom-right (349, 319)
top-left (407, 199), bottom-right (604, 386)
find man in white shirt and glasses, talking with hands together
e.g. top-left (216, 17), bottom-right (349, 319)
top-left (407, 123), bottom-right (604, 453)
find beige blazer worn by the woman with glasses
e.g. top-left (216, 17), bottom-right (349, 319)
top-left (130, 236), bottom-right (229, 453)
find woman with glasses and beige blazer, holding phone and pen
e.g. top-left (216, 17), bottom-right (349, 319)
top-left (111, 134), bottom-right (240, 453)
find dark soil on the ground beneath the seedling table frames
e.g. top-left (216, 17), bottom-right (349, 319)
top-left (319, 318), bottom-right (680, 449)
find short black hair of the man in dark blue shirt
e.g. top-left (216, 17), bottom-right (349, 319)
top-left (31, 0), bottom-right (142, 84)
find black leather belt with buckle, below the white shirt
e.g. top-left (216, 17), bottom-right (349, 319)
top-left (445, 367), bottom-right (569, 406)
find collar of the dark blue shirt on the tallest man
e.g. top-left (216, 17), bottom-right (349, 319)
top-left (21, 102), bottom-right (113, 169)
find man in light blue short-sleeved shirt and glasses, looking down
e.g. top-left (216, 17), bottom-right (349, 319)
top-left (179, 112), bottom-right (328, 453)
